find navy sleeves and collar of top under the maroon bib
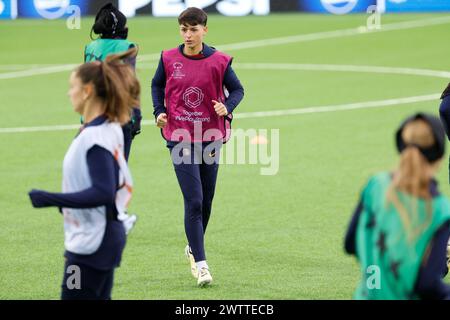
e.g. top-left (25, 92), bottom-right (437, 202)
top-left (152, 44), bottom-right (244, 118)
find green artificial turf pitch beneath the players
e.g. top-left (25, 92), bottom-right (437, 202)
top-left (0, 14), bottom-right (450, 299)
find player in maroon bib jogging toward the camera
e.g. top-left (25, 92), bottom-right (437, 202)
top-left (152, 8), bottom-right (244, 286)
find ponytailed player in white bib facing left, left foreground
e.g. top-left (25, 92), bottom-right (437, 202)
top-left (29, 49), bottom-right (140, 300)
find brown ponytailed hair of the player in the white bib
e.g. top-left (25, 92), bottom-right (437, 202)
top-left (75, 48), bottom-right (141, 125)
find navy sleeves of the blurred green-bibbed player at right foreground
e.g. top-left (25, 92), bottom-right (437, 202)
top-left (344, 181), bottom-right (450, 300)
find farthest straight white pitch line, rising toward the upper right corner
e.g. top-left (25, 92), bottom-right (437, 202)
top-left (0, 16), bottom-right (450, 80)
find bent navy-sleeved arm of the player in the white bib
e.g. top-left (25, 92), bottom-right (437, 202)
top-left (29, 145), bottom-right (118, 209)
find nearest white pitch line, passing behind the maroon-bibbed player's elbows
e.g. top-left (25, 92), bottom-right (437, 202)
top-left (0, 93), bottom-right (440, 134)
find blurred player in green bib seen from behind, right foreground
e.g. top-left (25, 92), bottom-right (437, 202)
top-left (345, 113), bottom-right (450, 300)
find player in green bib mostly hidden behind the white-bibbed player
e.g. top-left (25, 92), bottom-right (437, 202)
top-left (84, 3), bottom-right (142, 161)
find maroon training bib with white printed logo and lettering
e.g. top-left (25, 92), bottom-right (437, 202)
top-left (162, 48), bottom-right (232, 142)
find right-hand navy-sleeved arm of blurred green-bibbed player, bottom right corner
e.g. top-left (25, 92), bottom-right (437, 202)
top-left (416, 222), bottom-right (450, 300)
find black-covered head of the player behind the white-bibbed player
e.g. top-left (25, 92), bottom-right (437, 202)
top-left (91, 2), bottom-right (128, 40)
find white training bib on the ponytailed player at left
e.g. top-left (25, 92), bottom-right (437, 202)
top-left (62, 121), bottom-right (133, 254)
